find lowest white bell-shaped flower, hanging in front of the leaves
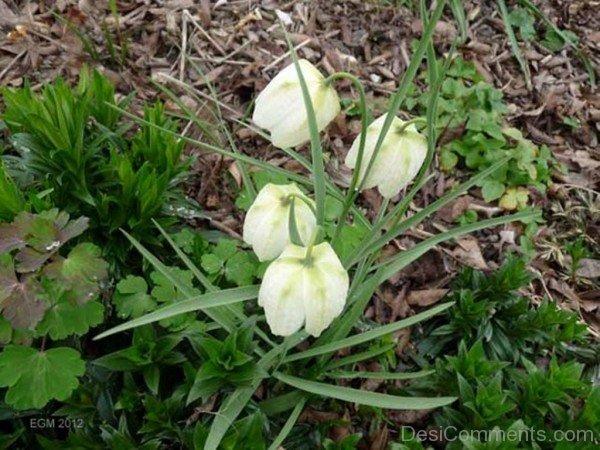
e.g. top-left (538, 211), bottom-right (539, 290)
top-left (258, 242), bottom-right (350, 337)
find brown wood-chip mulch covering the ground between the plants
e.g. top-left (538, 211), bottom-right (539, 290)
top-left (0, 0), bottom-right (600, 442)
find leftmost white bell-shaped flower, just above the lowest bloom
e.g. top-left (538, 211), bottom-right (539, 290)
top-left (244, 183), bottom-right (317, 261)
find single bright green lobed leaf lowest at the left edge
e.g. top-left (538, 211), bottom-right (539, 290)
top-left (0, 345), bottom-right (85, 410)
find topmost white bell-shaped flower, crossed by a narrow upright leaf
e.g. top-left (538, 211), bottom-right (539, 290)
top-left (252, 59), bottom-right (340, 148)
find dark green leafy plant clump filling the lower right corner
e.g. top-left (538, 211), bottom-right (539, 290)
top-left (397, 257), bottom-right (600, 449)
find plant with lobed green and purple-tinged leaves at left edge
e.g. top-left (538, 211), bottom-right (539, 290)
top-left (0, 210), bottom-right (107, 409)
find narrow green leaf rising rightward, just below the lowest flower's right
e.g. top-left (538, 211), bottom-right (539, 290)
top-left (284, 302), bottom-right (454, 363)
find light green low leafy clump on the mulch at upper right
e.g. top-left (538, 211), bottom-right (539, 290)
top-left (407, 58), bottom-right (556, 210)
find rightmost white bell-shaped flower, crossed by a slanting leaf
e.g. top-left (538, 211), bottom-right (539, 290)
top-left (346, 114), bottom-right (427, 198)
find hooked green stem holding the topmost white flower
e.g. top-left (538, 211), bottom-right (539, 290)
top-left (325, 72), bottom-right (369, 244)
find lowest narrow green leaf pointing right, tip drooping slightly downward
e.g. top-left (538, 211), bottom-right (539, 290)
top-left (274, 373), bottom-right (456, 410)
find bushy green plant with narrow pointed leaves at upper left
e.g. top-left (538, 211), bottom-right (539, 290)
top-left (2, 70), bottom-right (190, 264)
